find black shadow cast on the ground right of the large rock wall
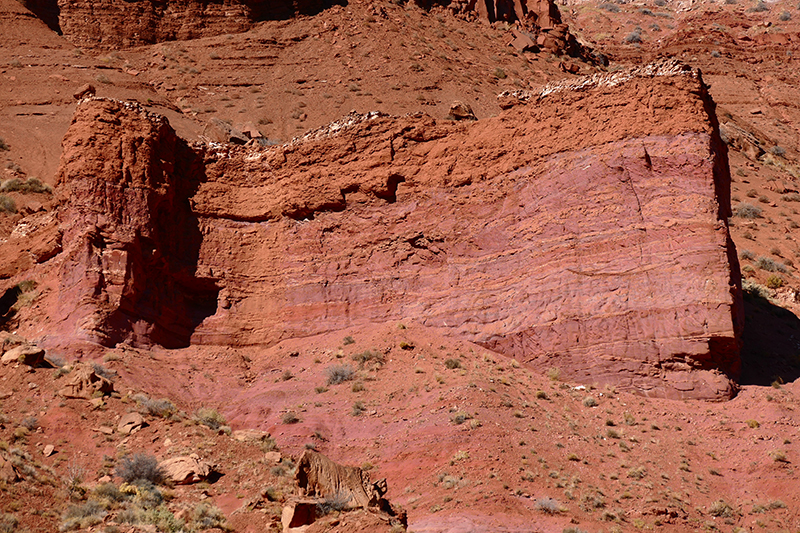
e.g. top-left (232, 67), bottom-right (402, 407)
top-left (740, 291), bottom-right (800, 386)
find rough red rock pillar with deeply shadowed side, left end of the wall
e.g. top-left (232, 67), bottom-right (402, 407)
top-left (52, 100), bottom-right (217, 347)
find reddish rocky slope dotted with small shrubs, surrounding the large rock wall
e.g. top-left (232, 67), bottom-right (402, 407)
top-left (0, 0), bottom-right (800, 533)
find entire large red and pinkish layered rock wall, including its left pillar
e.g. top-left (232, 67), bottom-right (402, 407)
top-left (42, 60), bottom-right (742, 399)
